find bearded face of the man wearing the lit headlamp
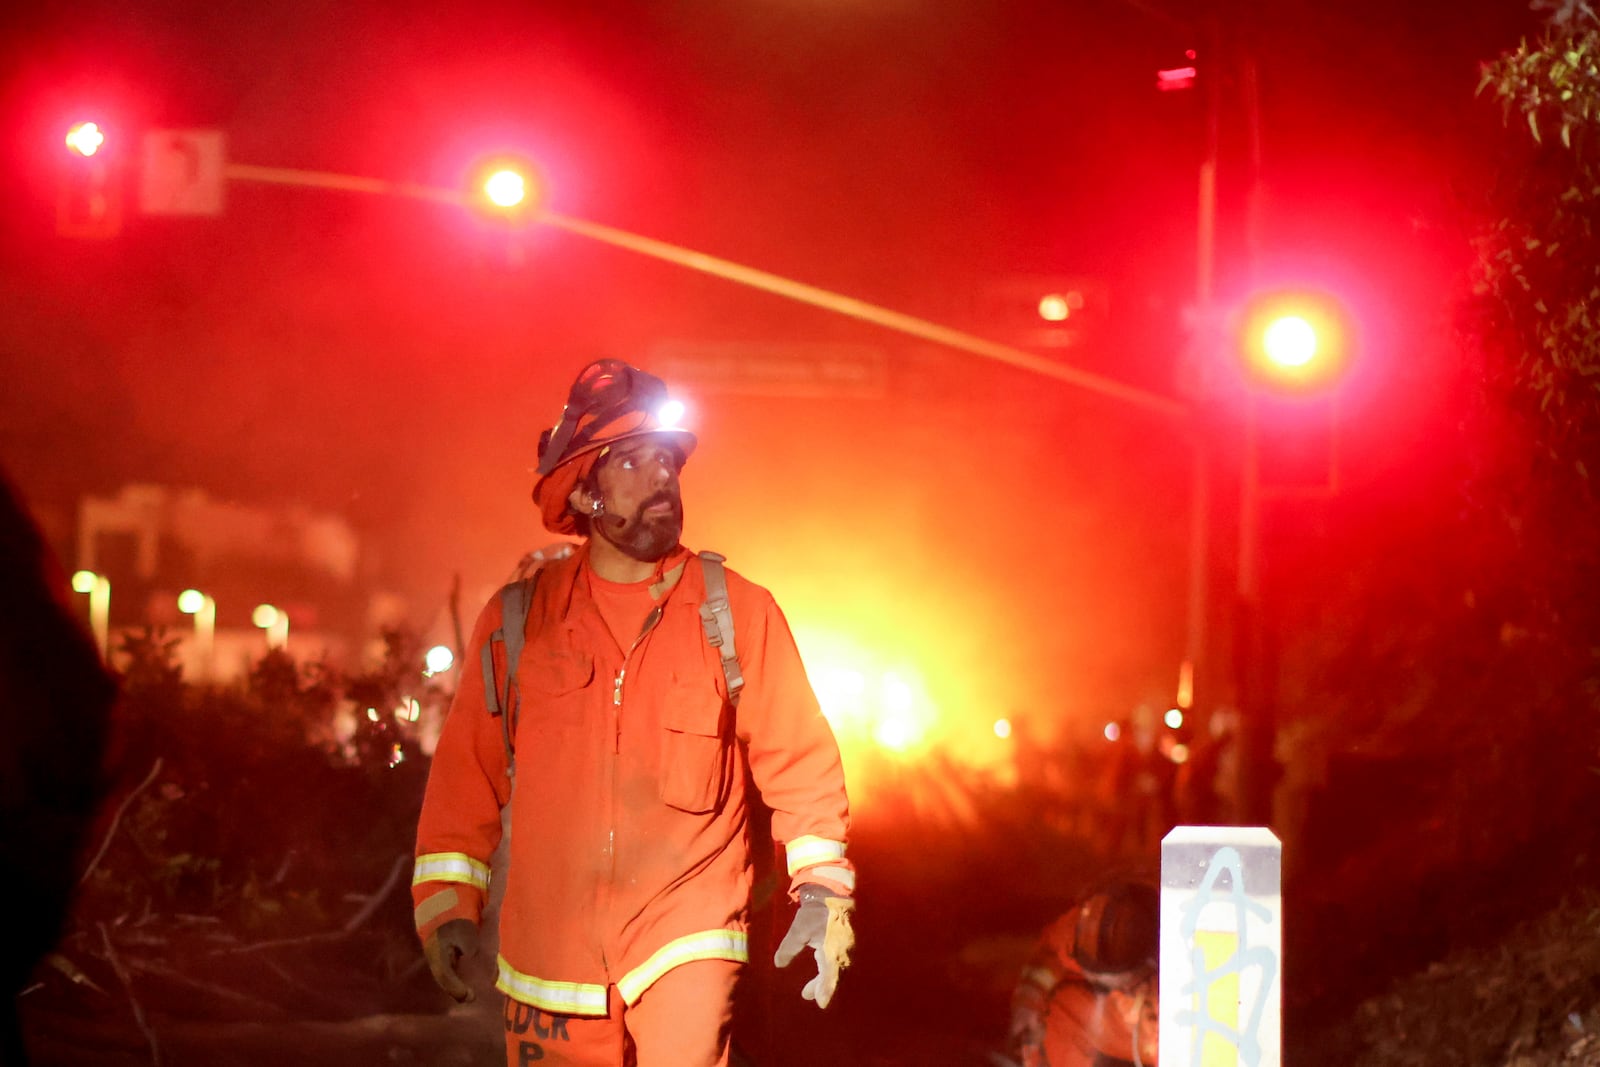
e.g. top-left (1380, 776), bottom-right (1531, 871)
top-left (590, 437), bottom-right (683, 563)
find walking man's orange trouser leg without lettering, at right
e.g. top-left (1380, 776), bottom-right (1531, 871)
top-left (622, 960), bottom-right (744, 1067)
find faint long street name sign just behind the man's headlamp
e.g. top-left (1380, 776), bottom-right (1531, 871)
top-left (648, 341), bottom-right (888, 400)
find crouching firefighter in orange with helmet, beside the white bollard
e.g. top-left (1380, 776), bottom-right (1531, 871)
top-left (1010, 880), bottom-right (1160, 1067)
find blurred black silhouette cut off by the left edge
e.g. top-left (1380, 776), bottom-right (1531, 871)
top-left (0, 474), bottom-right (115, 1067)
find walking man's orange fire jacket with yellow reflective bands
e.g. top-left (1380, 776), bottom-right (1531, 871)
top-left (411, 545), bottom-right (854, 1016)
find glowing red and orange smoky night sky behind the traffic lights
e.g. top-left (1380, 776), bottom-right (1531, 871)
top-left (0, 0), bottom-right (1534, 767)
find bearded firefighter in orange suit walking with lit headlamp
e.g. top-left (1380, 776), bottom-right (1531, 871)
top-left (413, 360), bottom-right (856, 1067)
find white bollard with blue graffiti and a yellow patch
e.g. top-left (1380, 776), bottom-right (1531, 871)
top-left (1160, 825), bottom-right (1283, 1067)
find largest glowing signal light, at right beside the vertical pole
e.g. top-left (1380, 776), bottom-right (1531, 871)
top-left (1238, 291), bottom-right (1350, 392)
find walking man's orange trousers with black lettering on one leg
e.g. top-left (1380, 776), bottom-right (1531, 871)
top-left (506, 960), bottom-right (742, 1067)
